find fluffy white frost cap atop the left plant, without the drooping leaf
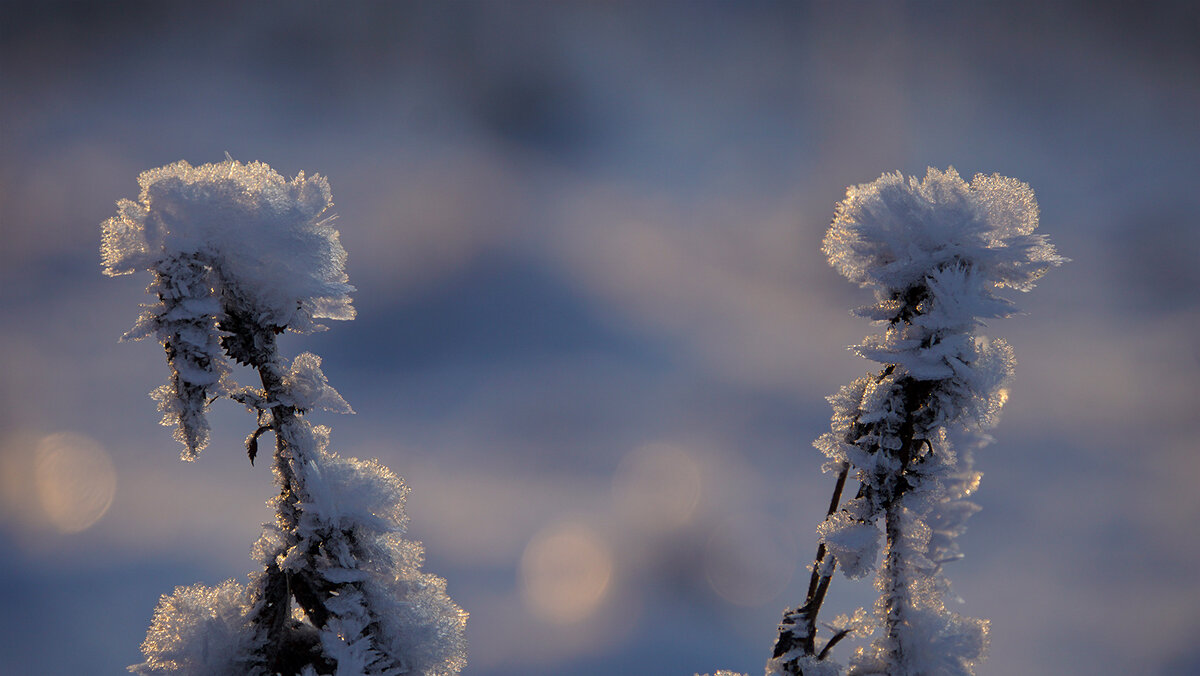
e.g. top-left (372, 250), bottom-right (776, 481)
top-left (101, 160), bottom-right (354, 331)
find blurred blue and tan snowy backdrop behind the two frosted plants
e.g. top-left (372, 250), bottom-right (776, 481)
top-left (0, 0), bottom-right (1200, 676)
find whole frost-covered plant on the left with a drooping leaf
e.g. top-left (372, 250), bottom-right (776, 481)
top-left (102, 158), bottom-right (467, 676)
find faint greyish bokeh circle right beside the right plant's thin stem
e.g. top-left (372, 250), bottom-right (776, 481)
top-left (704, 513), bottom-right (797, 606)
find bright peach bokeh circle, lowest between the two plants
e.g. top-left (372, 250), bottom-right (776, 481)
top-left (521, 524), bottom-right (613, 623)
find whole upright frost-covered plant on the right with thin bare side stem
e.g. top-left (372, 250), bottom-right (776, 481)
top-left (767, 168), bottom-right (1064, 676)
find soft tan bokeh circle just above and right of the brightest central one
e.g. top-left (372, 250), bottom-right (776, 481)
top-left (612, 443), bottom-right (702, 530)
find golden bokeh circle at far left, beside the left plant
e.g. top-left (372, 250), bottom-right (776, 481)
top-left (34, 432), bottom-right (116, 533)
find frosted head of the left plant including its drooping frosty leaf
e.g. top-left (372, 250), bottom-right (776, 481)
top-left (101, 160), bottom-right (354, 460)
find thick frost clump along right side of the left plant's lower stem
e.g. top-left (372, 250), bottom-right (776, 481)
top-left (280, 437), bottom-right (467, 676)
